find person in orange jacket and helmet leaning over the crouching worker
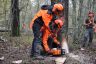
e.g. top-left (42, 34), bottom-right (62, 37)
top-left (30, 3), bottom-right (63, 56)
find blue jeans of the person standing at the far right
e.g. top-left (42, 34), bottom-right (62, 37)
top-left (83, 28), bottom-right (93, 47)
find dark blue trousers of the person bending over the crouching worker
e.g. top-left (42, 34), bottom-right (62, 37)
top-left (31, 24), bottom-right (42, 56)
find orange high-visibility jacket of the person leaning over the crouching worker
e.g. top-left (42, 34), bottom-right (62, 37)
top-left (30, 9), bottom-right (53, 31)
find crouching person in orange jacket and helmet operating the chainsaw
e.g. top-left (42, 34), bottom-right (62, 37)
top-left (42, 19), bottom-right (63, 55)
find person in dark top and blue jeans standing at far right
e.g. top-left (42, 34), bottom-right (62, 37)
top-left (81, 12), bottom-right (96, 50)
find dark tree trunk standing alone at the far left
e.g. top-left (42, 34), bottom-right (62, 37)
top-left (11, 0), bottom-right (20, 36)
